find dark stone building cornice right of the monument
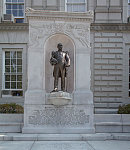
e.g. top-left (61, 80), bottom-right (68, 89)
top-left (91, 23), bottom-right (130, 32)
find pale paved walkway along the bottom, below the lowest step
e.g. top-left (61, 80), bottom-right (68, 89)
top-left (0, 140), bottom-right (130, 150)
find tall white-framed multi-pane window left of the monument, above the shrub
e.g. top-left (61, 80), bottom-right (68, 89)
top-left (3, 50), bottom-right (23, 96)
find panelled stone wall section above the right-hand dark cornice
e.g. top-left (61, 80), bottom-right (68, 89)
top-left (95, 0), bottom-right (128, 23)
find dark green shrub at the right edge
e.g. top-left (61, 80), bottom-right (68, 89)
top-left (118, 104), bottom-right (130, 114)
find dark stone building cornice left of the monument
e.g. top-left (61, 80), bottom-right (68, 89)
top-left (0, 23), bottom-right (29, 31)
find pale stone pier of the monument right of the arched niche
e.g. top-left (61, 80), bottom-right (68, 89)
top-left (74, 23), bottom-right (93, 104)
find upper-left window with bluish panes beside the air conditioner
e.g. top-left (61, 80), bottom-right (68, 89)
top-left (5, 0), bottom-right (24, 23)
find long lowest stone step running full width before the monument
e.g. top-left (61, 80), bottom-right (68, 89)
top-left (0, 133), bottom-right (130, 141)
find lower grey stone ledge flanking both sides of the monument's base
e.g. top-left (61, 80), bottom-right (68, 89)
top-left (0, 122), bottom-right (130, 133)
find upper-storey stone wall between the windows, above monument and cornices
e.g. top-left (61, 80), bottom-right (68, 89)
top-left (0, 0), bottom-right (128, 23)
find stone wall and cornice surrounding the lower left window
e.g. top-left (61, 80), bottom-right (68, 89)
top-left (0, 23), bottom-right (29, 105)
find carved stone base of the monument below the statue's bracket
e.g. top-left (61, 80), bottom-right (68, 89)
top-left (23, 105), bottom-right (95, 134)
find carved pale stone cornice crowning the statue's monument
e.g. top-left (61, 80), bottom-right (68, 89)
top-left (26, 8), bottom-right (94, 22)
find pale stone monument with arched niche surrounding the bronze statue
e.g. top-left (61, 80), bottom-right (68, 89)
top-left (23, 9), bottom-right (95, 133)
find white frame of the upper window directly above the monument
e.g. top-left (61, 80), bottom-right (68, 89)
top-left (65, 0), bottom-right (87, 13)
